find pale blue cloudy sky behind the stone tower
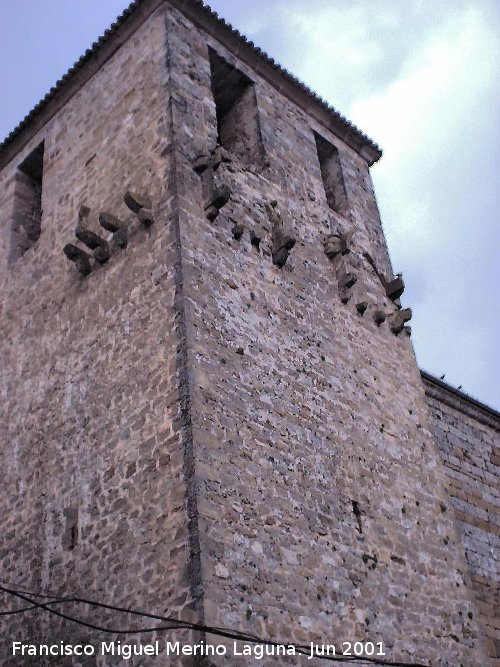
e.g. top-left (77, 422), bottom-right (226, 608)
top-left (0, 0), bottom-right (500, 409)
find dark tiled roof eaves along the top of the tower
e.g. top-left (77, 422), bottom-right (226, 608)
top-left (0, 0), bottom-right (382, 169)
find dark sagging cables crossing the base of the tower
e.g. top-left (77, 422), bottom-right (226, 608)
top-left (0, 582), bottom-right (427, 667)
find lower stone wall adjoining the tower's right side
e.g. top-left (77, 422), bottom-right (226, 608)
top-left (424, 378), bottom-right (500, 666)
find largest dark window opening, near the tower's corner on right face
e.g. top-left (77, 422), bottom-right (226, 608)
top-left (209, 49), bottom-right (264, 166)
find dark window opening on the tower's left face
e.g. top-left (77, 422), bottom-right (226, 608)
top-left (11, 142), bottom-right (44, 261)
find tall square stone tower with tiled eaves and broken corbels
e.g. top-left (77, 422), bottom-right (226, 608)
top-left (0, 0), bottom-right (498, 667)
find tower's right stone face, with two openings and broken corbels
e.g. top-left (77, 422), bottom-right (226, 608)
top-left (169, 2), bottom-right (487, 667)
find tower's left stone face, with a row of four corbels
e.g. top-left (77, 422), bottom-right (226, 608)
top-left (0, 3), bottom-right (198, 666)
